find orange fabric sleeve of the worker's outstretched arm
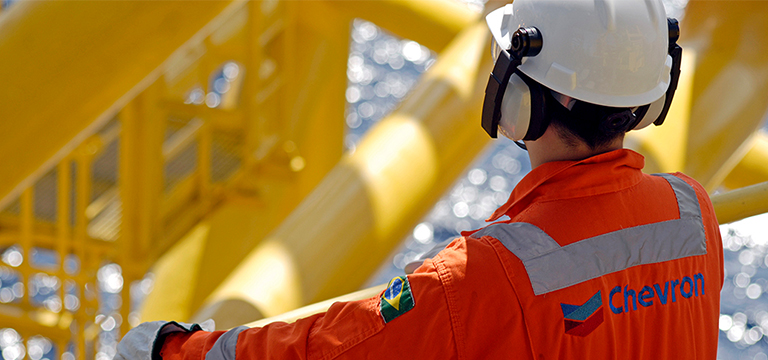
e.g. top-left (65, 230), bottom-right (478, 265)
top-left (161, 260), bottom-right (456, 360)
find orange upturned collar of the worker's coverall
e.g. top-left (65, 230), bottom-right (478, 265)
top-left (486, 149), bottom-right (645, 222)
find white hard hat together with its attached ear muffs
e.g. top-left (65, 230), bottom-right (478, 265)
top-left (483, 0), bottom-right (681, 140)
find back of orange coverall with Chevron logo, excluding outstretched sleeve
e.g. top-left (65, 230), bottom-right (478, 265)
top-left (434, 150), bottom-right (723, 358)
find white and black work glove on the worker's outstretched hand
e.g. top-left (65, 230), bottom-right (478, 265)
top-left (115, 319), bottom-right (216, 360)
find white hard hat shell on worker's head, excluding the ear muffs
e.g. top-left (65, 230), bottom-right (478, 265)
top-left (486, 0), bottom-right (672, 107)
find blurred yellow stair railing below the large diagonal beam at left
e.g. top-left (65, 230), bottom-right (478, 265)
top-left (0, 4), bottom-right (258, 358)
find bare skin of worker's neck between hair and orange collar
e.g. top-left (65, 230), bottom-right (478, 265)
top-left (525, 126), bottom-right (624, 168)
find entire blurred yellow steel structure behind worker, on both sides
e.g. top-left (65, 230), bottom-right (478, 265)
top-left (0, 0), bottom-right (768, 358)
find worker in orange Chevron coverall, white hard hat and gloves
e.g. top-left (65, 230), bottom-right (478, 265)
top-left (117, 0), bottom-right (723, 360)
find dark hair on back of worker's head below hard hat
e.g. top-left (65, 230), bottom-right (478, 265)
top-left (546, 92), bottom-right (637, 150)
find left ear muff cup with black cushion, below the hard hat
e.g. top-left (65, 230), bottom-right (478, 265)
top-left (498, 70), bottom-right (549, 141)
